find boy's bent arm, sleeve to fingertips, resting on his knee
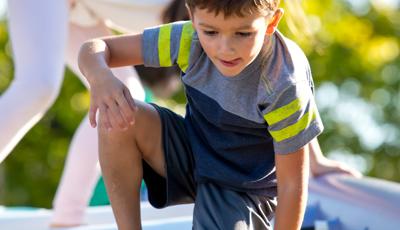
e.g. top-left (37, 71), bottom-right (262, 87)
top-left (78, 34), bottom-right (143, 129)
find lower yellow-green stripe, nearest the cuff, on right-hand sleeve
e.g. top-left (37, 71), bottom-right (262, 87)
top-left (270, 109), bottom-right (317, 142)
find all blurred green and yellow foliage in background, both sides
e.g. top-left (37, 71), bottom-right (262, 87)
top-left (0, 0), bottom-right (400, 207)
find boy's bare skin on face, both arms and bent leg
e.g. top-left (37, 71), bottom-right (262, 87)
top-left (79, 4), bottom-right (362, 229)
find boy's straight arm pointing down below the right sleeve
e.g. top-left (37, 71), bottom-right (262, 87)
top-left (274, 145), bottom-right (309, 230)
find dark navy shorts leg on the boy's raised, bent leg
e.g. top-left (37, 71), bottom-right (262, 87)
top-left (143, 104), bottom-right (196, 208)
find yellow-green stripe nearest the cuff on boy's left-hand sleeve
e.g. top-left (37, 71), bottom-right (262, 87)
top-left (158, 24), bottom-right (172, 67)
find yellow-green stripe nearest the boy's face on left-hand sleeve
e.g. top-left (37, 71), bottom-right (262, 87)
top-left (177, 22), bottom-right (194, 72)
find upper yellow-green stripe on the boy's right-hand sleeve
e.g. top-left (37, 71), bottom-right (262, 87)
top-left (264, 98), bottom-right (301, 125)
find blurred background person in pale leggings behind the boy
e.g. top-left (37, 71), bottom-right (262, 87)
top-left (0, 0), bottom-right (185, 226)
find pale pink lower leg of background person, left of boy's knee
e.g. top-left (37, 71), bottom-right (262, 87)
top-left (51, 116), bottom-right (100, 227)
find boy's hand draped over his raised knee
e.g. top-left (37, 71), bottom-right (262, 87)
top-left (89, 71), bottom-right (137, 130)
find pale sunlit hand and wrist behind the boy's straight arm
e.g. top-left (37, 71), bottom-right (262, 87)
top-left (309, 138), bottom-right (362, 178)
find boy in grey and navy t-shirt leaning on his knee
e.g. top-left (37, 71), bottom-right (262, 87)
top-left (79, 0), bottom-right (323, 230)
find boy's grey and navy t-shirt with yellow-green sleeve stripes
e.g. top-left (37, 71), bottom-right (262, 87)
top-left (142, 21), bottom-right (323, 196)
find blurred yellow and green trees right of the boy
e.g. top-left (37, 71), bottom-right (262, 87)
top-left (280, 0), bottom-right (400, 181)
